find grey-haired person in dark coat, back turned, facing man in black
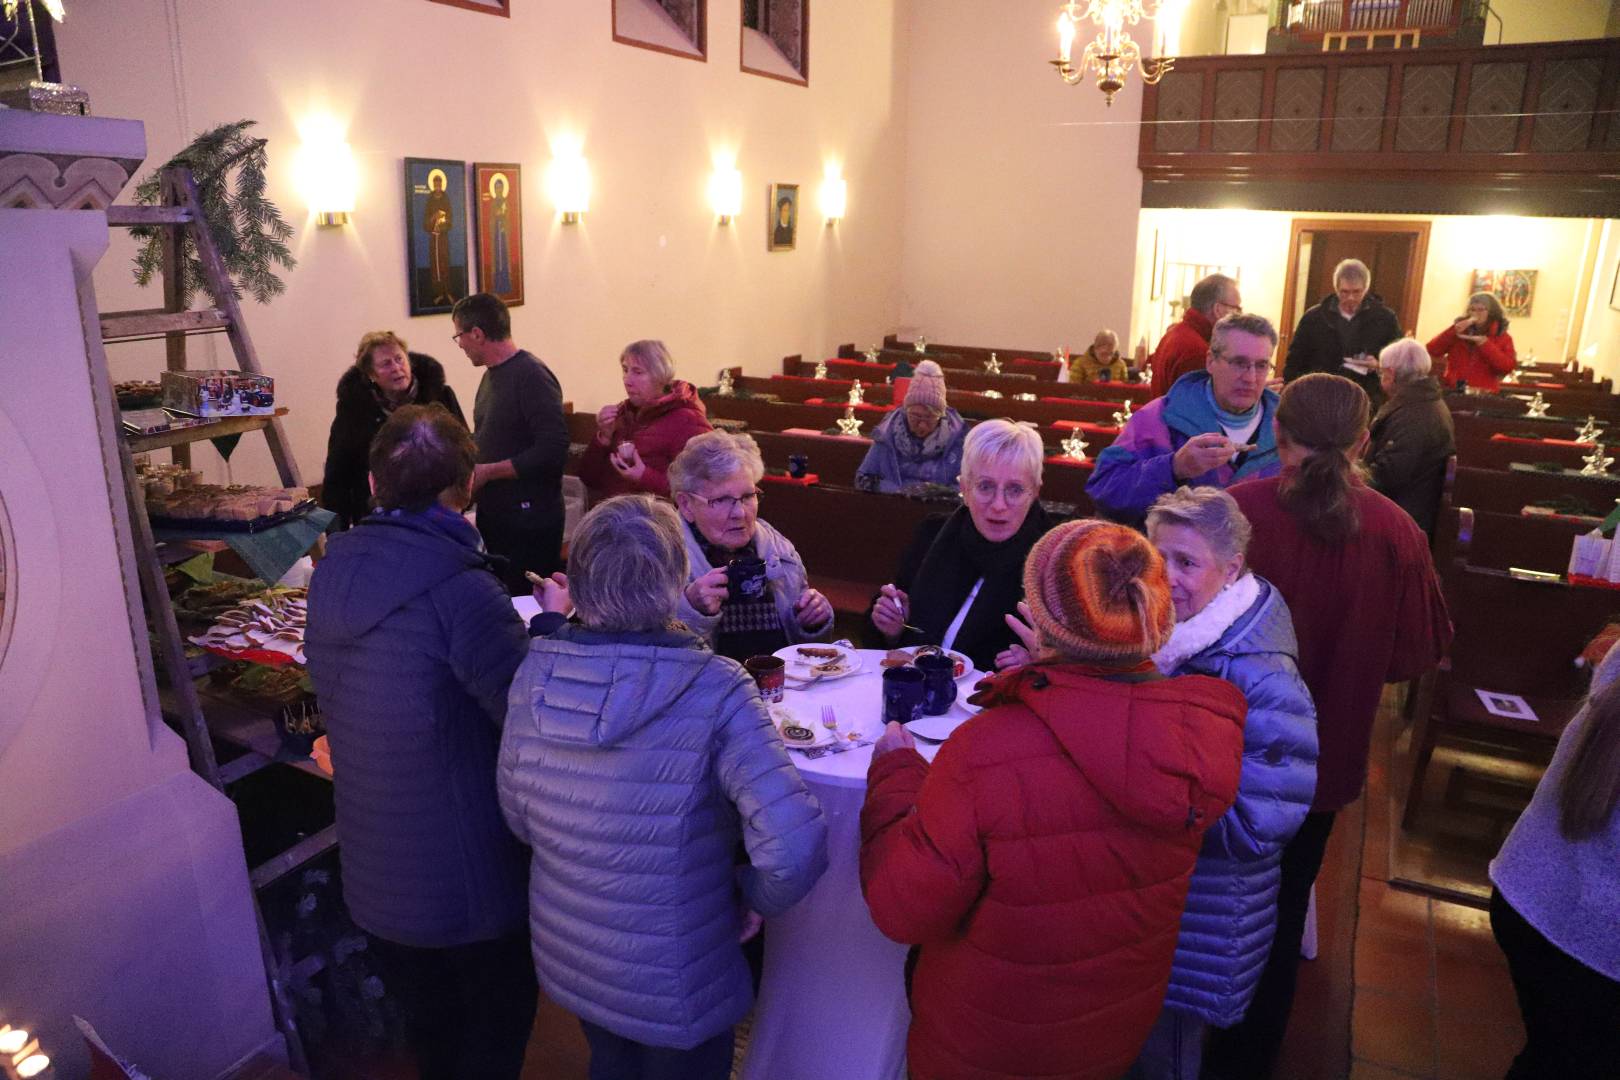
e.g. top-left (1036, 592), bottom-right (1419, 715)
top-left (1362, 337), bottom-right (1456, 536)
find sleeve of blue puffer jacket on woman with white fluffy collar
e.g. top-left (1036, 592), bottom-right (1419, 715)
top-left (1204, 654), bottom-right (1317, 860)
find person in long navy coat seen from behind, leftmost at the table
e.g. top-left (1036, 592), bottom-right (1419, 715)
top-left (305, 405), bottom-right (538, 1080)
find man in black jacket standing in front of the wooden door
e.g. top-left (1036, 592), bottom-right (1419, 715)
top-left (1283, 259), bottom-right (1401, 413)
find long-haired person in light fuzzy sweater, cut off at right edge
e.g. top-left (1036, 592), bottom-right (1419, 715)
top-left (1490, 649), bottom-right (1620, 1080)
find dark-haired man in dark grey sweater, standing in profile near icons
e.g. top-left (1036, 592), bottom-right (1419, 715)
top-left (450, 293), bottom-right (569, 596)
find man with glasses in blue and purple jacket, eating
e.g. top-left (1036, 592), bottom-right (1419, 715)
top-left (1085, 314), bottom-right (1281, 528)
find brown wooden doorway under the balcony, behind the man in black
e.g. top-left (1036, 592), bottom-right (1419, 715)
top-left (1277, 217), bottom-right (1429, 367)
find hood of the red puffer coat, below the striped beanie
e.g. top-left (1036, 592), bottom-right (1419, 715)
top-left (988, 664), bottom-right (1247, 832)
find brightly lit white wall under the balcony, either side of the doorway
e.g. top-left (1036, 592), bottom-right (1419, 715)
top-left (1131, 209), bottom-right (1600, 367)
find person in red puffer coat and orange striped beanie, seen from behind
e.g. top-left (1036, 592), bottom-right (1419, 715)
top-left (860, 520), bottom-right (1246, 1080)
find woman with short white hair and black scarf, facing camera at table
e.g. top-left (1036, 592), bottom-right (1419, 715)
top-left (867, 419), bottom-right (1056, 672)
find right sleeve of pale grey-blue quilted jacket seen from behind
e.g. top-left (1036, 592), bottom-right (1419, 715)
top-left (716, 670), bottom-right (826, 916)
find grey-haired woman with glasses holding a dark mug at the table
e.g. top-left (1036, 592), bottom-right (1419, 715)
top-left (669, 431), bottom-right (833, 661)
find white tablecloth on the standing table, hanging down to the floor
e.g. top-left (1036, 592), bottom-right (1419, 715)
top-left (740, 649), bottom-right (970, 1080)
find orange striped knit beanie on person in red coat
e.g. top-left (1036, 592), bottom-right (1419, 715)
top-left (1024, 518), bottom-right (1176, 662)
